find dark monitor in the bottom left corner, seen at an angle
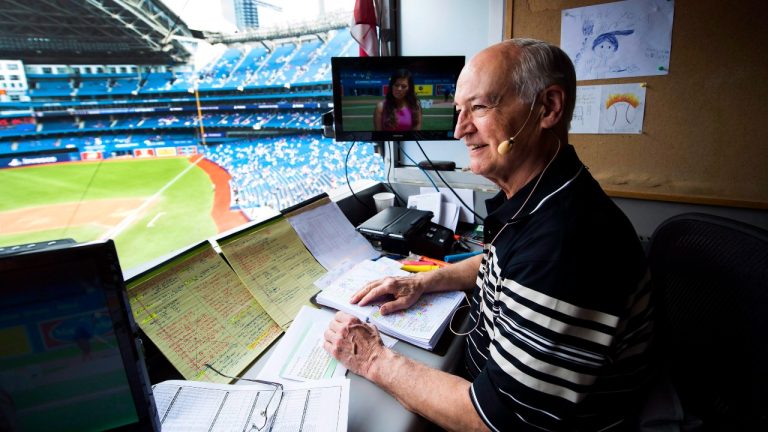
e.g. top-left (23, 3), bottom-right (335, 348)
top-left (0, 240), bottom-right (160, 431)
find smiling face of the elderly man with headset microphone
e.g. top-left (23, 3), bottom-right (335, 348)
top-left (454, 50), bottom-right (534, 184)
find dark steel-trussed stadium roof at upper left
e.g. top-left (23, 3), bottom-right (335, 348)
top-left (0, 0), bottom-right (200, 64)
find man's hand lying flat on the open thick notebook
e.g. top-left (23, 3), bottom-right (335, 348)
top-left (349, 276), bottom-right (424, 315)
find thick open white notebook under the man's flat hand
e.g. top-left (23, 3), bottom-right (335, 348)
top-left (317, 258), bottom-right (464, 350)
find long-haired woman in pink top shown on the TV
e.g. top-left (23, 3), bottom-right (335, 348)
top-left (373, 69), bottom-right (421, 131)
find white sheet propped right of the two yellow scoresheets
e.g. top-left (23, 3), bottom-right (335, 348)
top-left (286, 198), bottom-right (379, 271)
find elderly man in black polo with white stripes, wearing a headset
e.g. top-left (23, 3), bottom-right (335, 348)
top-left (325, 39), bottom-right (652, 430)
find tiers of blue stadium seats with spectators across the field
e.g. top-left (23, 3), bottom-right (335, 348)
top-left (0, 29), bottom-right (384, 215)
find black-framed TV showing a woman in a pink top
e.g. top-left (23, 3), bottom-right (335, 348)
top-left (331, 56), bottom-right (464, 141)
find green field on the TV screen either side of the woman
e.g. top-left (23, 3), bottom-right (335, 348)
top-left (341, 96), bottom-right (454, 131)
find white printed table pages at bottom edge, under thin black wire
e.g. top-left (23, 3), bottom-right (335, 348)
top-left (152, 379), bottom-right (349, 432)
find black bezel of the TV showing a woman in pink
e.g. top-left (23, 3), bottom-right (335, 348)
top-left (331, 55), bottom-right (466, 142)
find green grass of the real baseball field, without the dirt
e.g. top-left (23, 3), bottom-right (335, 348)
top-left (0, 158), bottom-right (217, 270)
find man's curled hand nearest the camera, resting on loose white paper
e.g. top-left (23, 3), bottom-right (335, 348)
top-left (323, 312), bottom-right (386, 378)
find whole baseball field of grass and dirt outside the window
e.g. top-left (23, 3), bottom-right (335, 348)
top-left (0, 156), bottom-right (247, 270)
